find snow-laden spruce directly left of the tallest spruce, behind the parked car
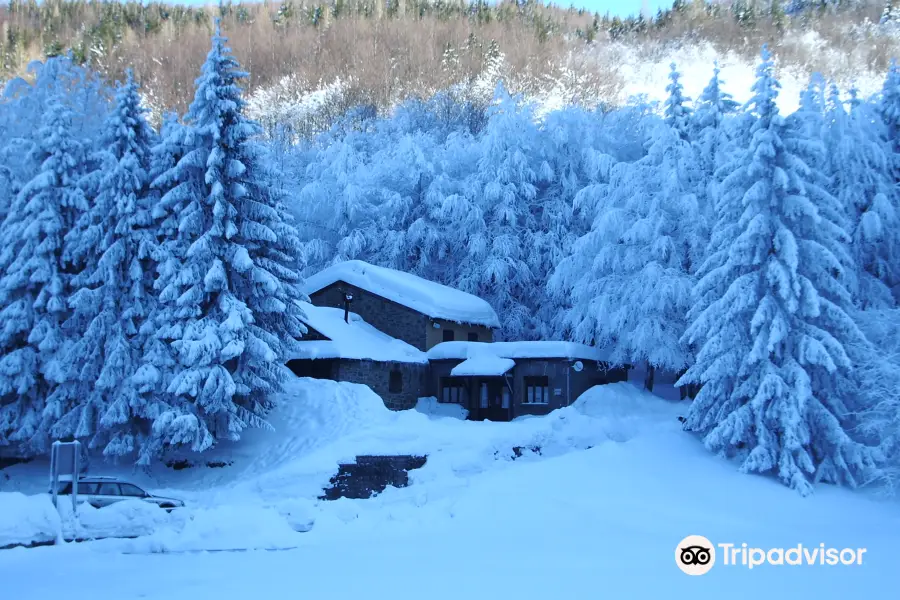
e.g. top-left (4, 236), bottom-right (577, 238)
top-left (54, 70), bottom-right (164, 457)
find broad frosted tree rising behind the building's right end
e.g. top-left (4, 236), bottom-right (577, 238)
top-left (550, 116), bottom-right (701, 389)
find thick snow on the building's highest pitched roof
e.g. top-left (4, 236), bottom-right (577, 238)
top-left (304, 260), bottom-right (500, 327)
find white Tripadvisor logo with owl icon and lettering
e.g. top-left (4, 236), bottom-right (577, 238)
top-left (675, 535), bottom-right (866, 575)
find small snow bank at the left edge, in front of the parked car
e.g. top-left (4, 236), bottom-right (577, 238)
top-left (0, 492), bottom-right (60, 548)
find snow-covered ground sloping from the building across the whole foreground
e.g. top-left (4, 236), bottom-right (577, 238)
top-left (0, 379), bottom-right (900, 600)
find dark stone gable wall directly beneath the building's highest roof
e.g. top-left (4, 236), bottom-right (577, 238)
top-left (310, 281), bottom-right (430, 351)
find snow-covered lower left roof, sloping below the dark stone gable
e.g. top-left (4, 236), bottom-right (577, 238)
top-left (292, 302), bottom-right (428, 364)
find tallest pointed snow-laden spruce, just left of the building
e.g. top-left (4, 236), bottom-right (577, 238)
top-left (142, 24), bottom-right (304, 452)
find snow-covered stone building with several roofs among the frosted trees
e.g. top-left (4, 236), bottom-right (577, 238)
top-left (287, 261), bottom-right (627, 421)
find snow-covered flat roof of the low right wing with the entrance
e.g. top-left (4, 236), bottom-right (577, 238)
top-left (428, 341), bottom-right (609, 361)
